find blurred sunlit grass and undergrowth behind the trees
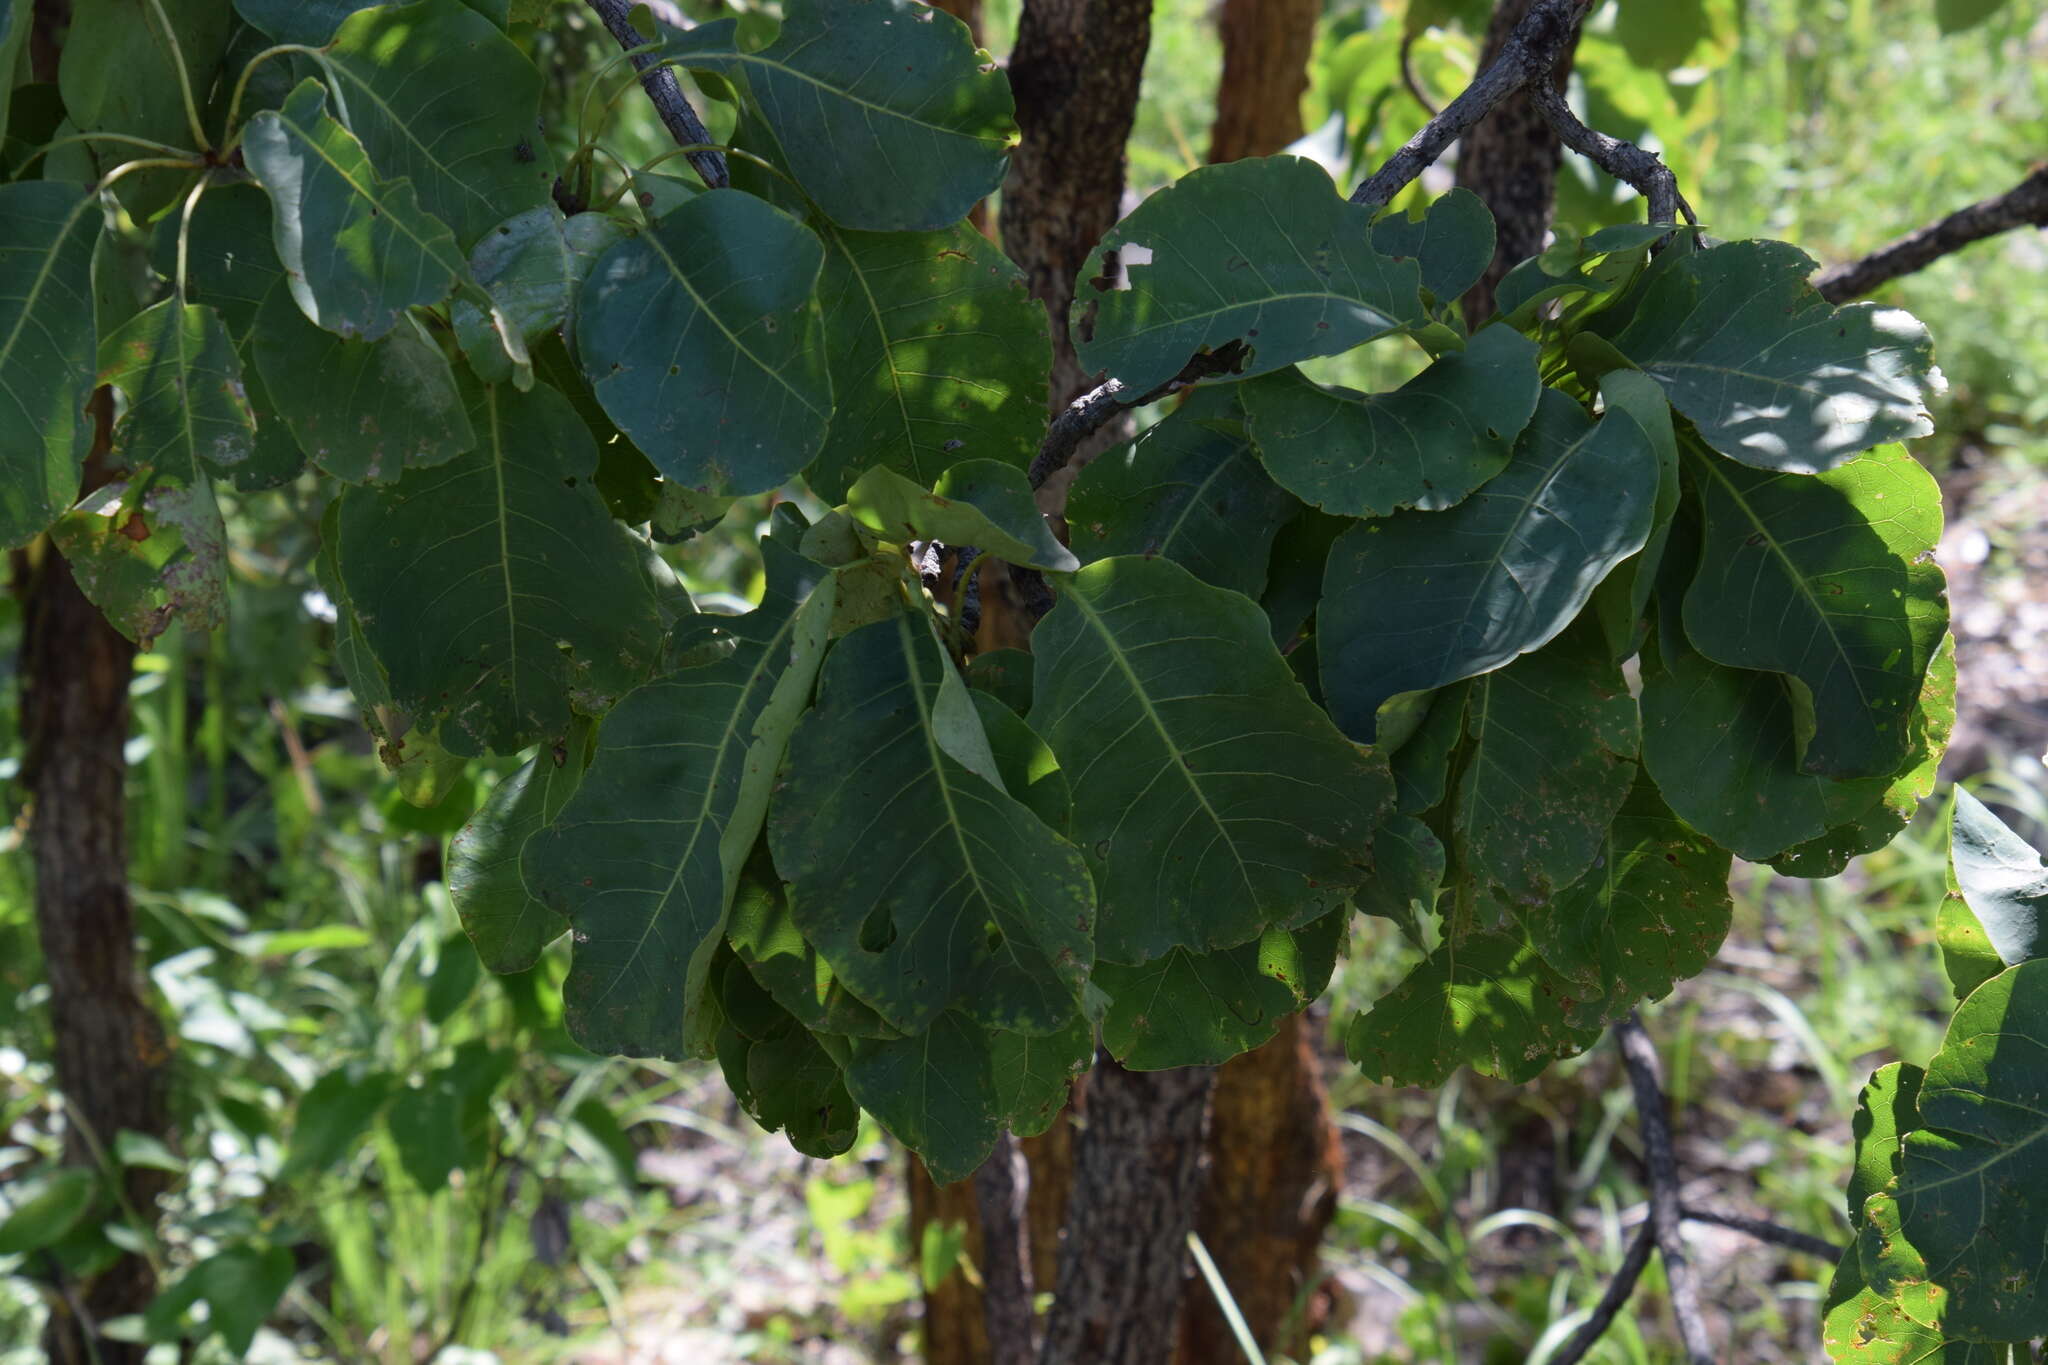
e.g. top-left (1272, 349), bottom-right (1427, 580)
top-left (0, 0), bottom-right (2048, 1365)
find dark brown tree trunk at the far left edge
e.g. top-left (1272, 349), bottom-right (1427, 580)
top-left (20, 389), bottom-right (170, 1365)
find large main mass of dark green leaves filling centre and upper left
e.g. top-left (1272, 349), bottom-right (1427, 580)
top-left (0, 0), bottom-right (1954, 1179)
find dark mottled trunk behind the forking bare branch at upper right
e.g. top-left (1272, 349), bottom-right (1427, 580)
top-left (1458, 0), bottom-right (1577, 325)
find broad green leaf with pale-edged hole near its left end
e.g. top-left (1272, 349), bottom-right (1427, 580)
top-left (1071, 156), bottom-right (1430, 393)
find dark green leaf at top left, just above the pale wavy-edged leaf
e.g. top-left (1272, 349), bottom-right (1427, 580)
top-left (327, 0), bottom-right (555, 248)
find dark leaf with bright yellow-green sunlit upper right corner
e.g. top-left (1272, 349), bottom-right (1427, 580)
top-left (1686, 446), bottom-right (1948, 778)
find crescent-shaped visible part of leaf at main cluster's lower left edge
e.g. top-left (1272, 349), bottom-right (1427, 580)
top-left (446, 718), bottom-right (592, 974)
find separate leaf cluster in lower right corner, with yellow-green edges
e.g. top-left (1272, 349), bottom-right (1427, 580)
top-left (1825, 788), bottom-right (2048, 1365)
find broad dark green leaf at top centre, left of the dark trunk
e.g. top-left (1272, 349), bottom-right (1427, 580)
top-left (662, 0), bottom-right (1016, 231)
